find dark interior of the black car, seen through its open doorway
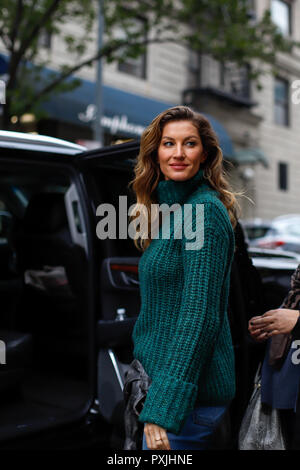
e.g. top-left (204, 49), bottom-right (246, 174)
top-left (0, 164), bottom-right (89, 440)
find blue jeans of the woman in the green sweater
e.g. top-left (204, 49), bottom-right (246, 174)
top-left (143, 406), bottom-right (227, 450)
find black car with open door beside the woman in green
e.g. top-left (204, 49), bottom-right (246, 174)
top-left (0, 131), bottom-right (298, 449)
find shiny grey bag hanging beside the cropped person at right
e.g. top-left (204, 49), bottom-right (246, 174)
top-left (238, 363), bottom-right (286, 450)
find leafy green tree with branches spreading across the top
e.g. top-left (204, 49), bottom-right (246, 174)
top-left (0, 0), bottom-right (299, 128)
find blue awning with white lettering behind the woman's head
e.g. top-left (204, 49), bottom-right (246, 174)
top-left (39, 74), bottom-right (234, 158)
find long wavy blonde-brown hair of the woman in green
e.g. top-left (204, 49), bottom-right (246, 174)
top-left (129, 106), bottom-right (239, 251)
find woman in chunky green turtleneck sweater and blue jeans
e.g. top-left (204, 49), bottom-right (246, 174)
top-left (126, 106), bottom-right (237, 450)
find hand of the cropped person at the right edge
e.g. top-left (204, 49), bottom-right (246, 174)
top-left (248, 308), bottom-right (299, 341)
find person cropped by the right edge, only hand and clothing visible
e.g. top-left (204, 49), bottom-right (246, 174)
top-left (249, 264), bottom-right (300, 449)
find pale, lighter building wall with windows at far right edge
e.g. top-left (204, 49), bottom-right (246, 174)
top-left (253, 0), bottom-right (300, 218)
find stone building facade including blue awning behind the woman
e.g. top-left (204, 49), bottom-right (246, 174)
top-left (0, 0), bottom-right (300, 219)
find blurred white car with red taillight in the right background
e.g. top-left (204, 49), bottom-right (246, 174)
top-left (243, 214), bottom-right (300, 253)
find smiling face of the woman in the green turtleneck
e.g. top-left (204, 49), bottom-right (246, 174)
top-left (157, 121), bottom-right (206, 181)
